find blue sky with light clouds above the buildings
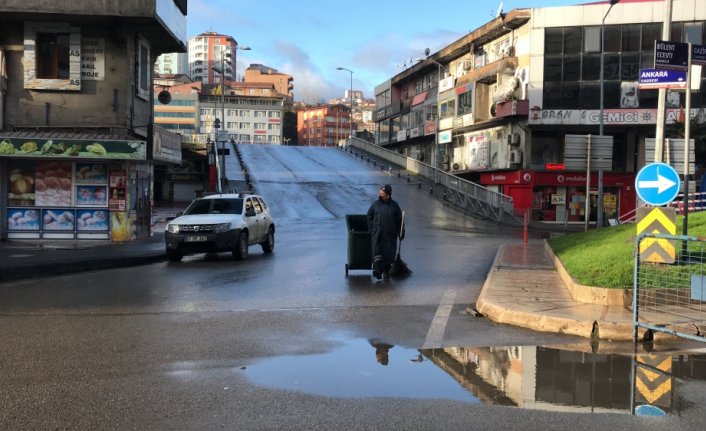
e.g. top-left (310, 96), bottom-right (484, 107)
top-left (186, 0), bottom-right (576, 103)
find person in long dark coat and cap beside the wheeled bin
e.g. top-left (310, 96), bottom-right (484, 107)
top-left (368, 184), bottom-right (404, 279)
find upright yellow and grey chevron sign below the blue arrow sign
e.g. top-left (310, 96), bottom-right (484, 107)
top-left (637, 207), bottom-right (677, 263)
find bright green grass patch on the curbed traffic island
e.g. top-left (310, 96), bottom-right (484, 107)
top-left (547, 211), bottom-right (706, 289)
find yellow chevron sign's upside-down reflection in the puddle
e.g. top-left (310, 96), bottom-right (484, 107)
top-left (635, 354), bottom-right (673, 409)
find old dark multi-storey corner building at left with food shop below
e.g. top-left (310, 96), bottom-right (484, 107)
top-left (0, 0), bottom-right (187, 241)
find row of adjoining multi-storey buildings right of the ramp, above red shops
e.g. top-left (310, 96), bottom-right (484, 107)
top-left (375, 0), bottom-right (706, 223)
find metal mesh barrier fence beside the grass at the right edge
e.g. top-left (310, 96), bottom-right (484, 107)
top-left (633, 234), bottom-right (706, 342)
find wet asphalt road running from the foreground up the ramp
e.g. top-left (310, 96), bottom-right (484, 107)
top-left (0, 146), bottom-right (704, 430)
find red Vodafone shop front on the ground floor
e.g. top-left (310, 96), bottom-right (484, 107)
top-left (480, 170), bottom-right (636, 225)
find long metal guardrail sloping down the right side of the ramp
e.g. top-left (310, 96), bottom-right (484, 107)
top-left (347, 138), bottom-right (522, 224)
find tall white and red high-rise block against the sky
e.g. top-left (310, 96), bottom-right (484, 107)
top-left (188, 32), bottom-right (238, 84)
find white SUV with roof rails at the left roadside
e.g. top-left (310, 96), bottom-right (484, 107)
top-left (164, 193), bottom-right (275, 262)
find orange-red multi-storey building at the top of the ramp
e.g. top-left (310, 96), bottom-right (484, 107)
top-left (297, 104), bottom-right (356, 147)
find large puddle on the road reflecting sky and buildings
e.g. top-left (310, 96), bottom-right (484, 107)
top-left (240, 339), bottom-right (706, 415)
